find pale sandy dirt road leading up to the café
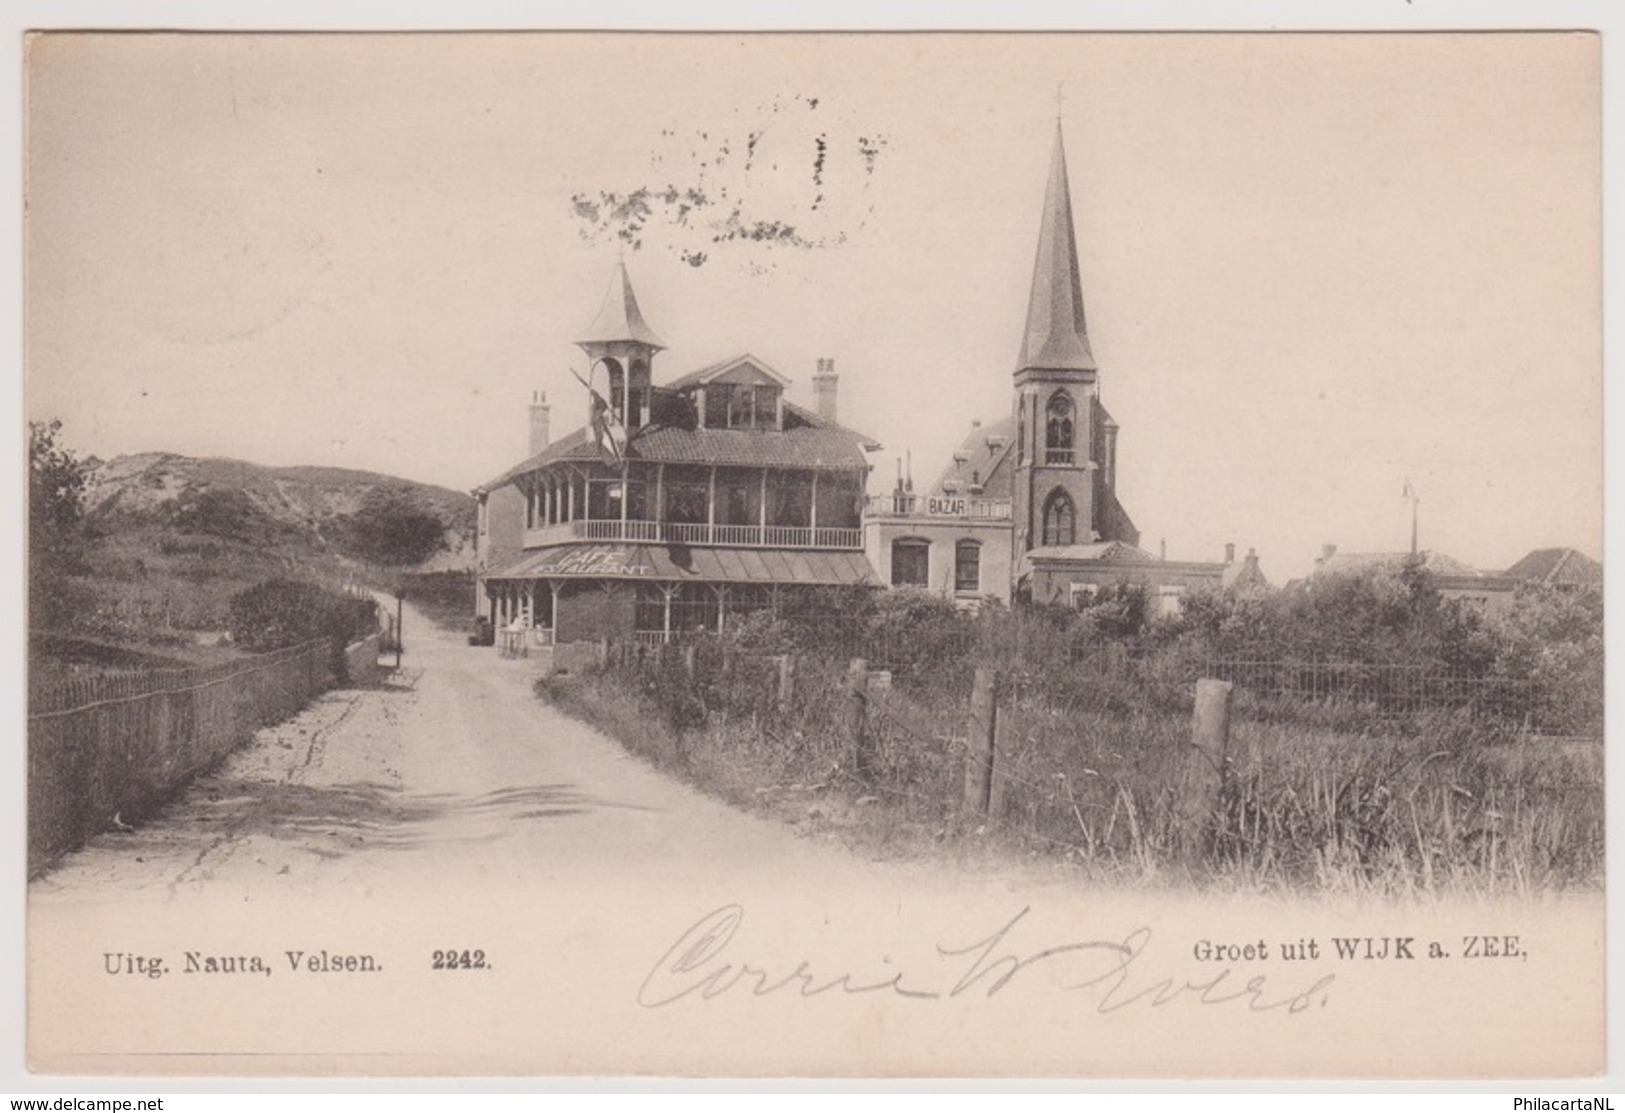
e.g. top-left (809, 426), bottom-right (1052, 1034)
top-left (34, 614), bottom-right (877, 903)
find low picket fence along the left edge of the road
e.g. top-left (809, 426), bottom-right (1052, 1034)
top-left (28, 639), bottom-right (338, 876)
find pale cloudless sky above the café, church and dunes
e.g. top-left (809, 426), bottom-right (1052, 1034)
top-left (24, 34), bottom-right (1602, 582)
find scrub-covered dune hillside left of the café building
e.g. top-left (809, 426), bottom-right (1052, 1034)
top-left (31, 453), bottom-right (475, 655)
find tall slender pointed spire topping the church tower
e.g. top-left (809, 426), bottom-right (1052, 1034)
top-left (1017, 120), bottom-right (1095, 370)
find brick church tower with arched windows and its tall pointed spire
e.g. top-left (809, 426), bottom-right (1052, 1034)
top-left (1012, 120), bottom-right (1139, 567)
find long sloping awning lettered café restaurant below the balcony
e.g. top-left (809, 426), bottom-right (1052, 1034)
top-left (484, 544), bottom-right (881, 587)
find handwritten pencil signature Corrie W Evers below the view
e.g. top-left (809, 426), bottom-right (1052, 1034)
top-left (637, 905), bottom-right (1336, 1014)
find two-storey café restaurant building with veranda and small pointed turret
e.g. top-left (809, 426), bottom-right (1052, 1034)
top-left (475, 265), bottom-right (881, 647)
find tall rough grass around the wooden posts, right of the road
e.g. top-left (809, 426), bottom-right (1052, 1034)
top-left (538, 663), bottom-right (1604, 899)
